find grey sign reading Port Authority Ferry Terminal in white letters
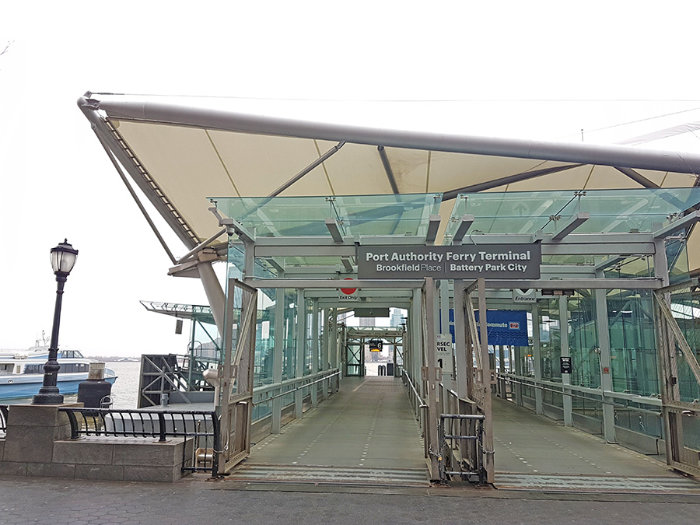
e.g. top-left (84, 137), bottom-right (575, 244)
top-left (357, 243), bottom-right (542, 279)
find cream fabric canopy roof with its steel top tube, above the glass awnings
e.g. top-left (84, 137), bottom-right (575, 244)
top-left (78, 93), bottom-right (700, 269)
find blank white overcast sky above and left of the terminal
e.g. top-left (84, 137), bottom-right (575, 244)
top-left (0, 0), bottom-right (700, 356)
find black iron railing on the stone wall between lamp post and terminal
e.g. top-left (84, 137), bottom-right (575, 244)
top-left (60, 408), bottom-right (221, 476)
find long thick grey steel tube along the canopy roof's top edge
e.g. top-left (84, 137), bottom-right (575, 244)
top-left (91, 94), bottom-right (700, 173)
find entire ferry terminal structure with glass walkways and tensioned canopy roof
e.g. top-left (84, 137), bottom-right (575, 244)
top-left (4, 93), bottom-right (700, 491)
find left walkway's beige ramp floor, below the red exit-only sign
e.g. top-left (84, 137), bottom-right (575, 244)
top-left (230, 377), bottom-right (428, 486)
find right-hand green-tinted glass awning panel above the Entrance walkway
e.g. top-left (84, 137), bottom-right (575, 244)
top-left (445, 188), bottom-right (700, 238)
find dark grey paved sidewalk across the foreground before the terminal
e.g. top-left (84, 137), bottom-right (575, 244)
top-left (0, 477), bottom-right (700, 525)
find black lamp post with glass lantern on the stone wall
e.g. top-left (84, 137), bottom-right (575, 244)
top-left (32, 239), bottom-right (78, 405)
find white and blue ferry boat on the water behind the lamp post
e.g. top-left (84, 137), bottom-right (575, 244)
top-left (0, 346), bottom-right (117, 402)
